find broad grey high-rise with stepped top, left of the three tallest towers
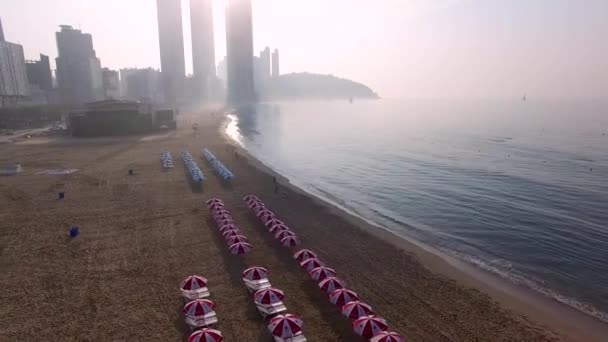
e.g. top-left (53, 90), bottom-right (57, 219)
top-left (56, 25), bottom-right (104, 106)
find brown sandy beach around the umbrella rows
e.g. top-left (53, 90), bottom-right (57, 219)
top-left (0, 113), bottom-right (608, 342)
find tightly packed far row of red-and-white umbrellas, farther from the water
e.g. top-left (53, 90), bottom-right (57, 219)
top-left (207, 198), bottom-right (253, 255)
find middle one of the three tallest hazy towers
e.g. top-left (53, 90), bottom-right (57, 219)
top-left (190, 0), bottom-right (215, 100)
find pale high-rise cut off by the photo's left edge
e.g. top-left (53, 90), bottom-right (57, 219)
top-left (0, 16), bottom-right (30, 106)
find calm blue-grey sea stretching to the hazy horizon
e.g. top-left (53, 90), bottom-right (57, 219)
top-left (228, 99), bottom-right (608, 321)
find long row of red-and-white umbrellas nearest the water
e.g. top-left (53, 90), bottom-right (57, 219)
top-left (243, 195), bottom-right (405, 342)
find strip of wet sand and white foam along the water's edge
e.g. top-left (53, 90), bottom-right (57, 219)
top-left (218, 116), bottom-right (608, 342)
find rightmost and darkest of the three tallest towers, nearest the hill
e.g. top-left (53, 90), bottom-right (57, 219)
top-left (226, 0), bottom-right (256, 104)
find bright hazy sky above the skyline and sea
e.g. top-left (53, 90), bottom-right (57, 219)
top-left (0, 0), bottom-right (608, 97)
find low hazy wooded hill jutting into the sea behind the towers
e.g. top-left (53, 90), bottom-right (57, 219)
top-left (258, 72), bottom-right (380, 100)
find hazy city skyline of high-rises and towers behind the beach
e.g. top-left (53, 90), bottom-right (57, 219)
top-left (0, 0), bottom-right (279, 108)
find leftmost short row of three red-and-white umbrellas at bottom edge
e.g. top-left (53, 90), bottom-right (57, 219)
top-left (180, 275), bottom-right (224, 342)
